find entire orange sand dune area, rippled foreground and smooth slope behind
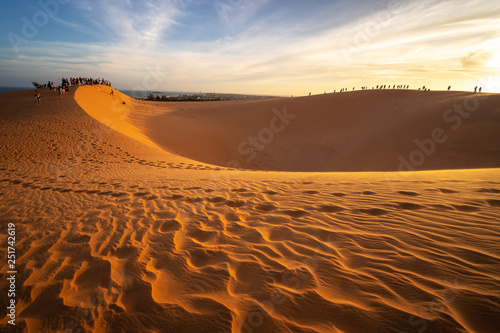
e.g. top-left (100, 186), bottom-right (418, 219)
top-left (0, 86), bottom-right (500, 333)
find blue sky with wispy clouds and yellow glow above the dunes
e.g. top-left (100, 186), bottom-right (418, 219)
top-left (0, 0), bottom-right (500, 96)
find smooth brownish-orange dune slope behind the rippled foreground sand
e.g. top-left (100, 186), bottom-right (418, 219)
top-left (77, 87), bottom-right (500, 171)
